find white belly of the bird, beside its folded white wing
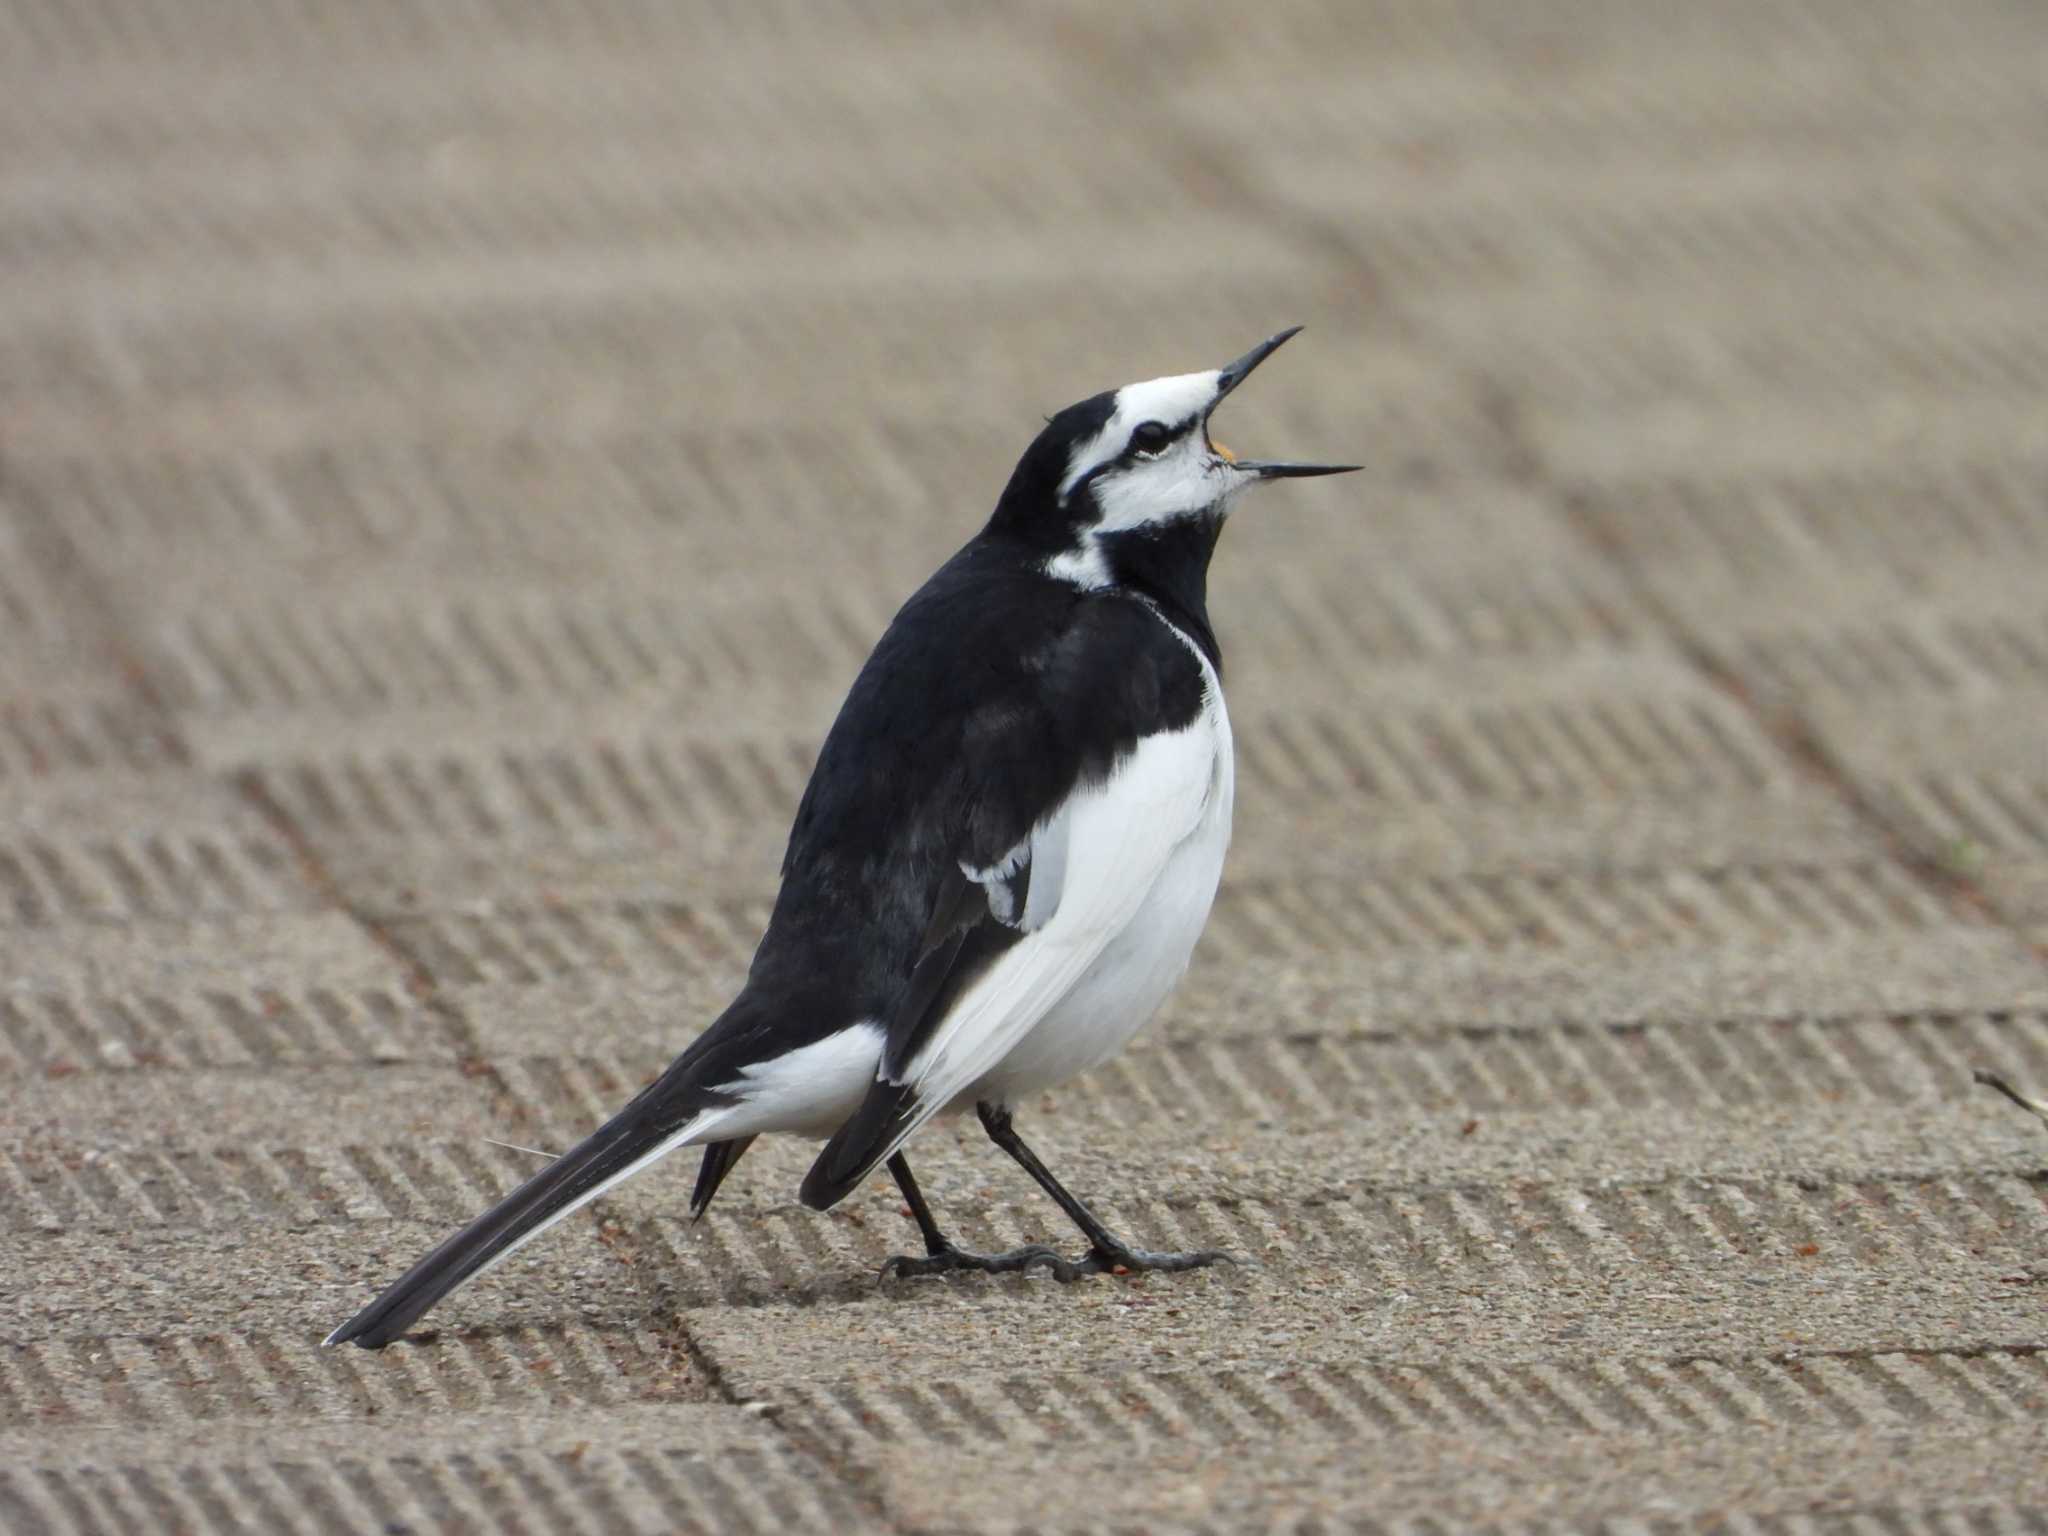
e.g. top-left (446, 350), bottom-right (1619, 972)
top-left (974, 684), bottom-right (1237, 1104)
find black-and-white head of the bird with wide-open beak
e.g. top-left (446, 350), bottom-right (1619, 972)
top-left (995, 326), bottom-right (1358, 586)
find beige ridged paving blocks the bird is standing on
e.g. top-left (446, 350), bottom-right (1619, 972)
top-left (0, 0), bottom-right (2048, 1534)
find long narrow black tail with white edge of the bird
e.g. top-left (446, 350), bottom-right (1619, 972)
top-left (324, 1063), bottom-right (721, 1350)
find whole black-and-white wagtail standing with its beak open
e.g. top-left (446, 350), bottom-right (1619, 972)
top-left (326, 326), bottom-right (1358, 1350)
